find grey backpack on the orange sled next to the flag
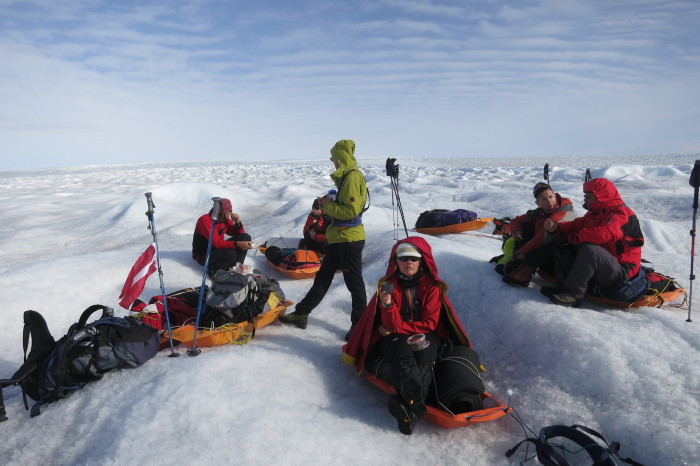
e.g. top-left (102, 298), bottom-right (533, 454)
top-left (202, 270), bottom-right (281, 327)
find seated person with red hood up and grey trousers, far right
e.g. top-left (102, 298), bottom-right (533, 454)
top-left (540, 178), bottom-right (644, 307)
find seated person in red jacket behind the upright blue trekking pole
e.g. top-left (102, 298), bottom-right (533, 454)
top-left (192, 198), bottom-right (253, 276)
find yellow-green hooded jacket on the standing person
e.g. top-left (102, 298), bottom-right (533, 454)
top-left (323, 139), bottom-right (367, 244)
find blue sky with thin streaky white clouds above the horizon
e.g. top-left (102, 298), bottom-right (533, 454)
top-left (0, 0), bottom-right (700, 170)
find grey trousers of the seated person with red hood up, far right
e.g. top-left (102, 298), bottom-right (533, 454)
top-left (555, 243), bottom-right (627, 299)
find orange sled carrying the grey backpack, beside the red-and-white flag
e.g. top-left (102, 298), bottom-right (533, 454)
top-left (160, 301), bottom-right (294, 348)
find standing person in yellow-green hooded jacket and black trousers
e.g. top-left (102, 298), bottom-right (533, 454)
top-left (279, 139), bottom-right (367, 340)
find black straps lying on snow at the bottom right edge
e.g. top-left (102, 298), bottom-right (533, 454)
top-left (506, 424), bottom-right (643, 466)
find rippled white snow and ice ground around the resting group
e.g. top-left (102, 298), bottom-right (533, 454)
top-left (0, 154), bottom-right (700, 465)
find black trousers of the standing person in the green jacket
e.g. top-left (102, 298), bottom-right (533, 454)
top-left (295, 240), bottom-right (367, 325)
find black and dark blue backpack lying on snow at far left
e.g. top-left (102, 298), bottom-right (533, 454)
top-left (0, 304), bottom-right (159, 421)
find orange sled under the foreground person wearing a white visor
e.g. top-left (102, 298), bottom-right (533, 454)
top-left (363, 371), bottom-right (513, 429)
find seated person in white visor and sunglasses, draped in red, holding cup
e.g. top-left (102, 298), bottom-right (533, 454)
top-left (343, 237), bottom-right (470, 435)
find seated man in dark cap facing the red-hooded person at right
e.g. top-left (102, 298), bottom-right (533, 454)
top-left (497, 182), bottom-right (576, 287)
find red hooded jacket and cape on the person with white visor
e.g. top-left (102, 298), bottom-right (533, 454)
top-left (342, 236), bottom-right (471, 372)
